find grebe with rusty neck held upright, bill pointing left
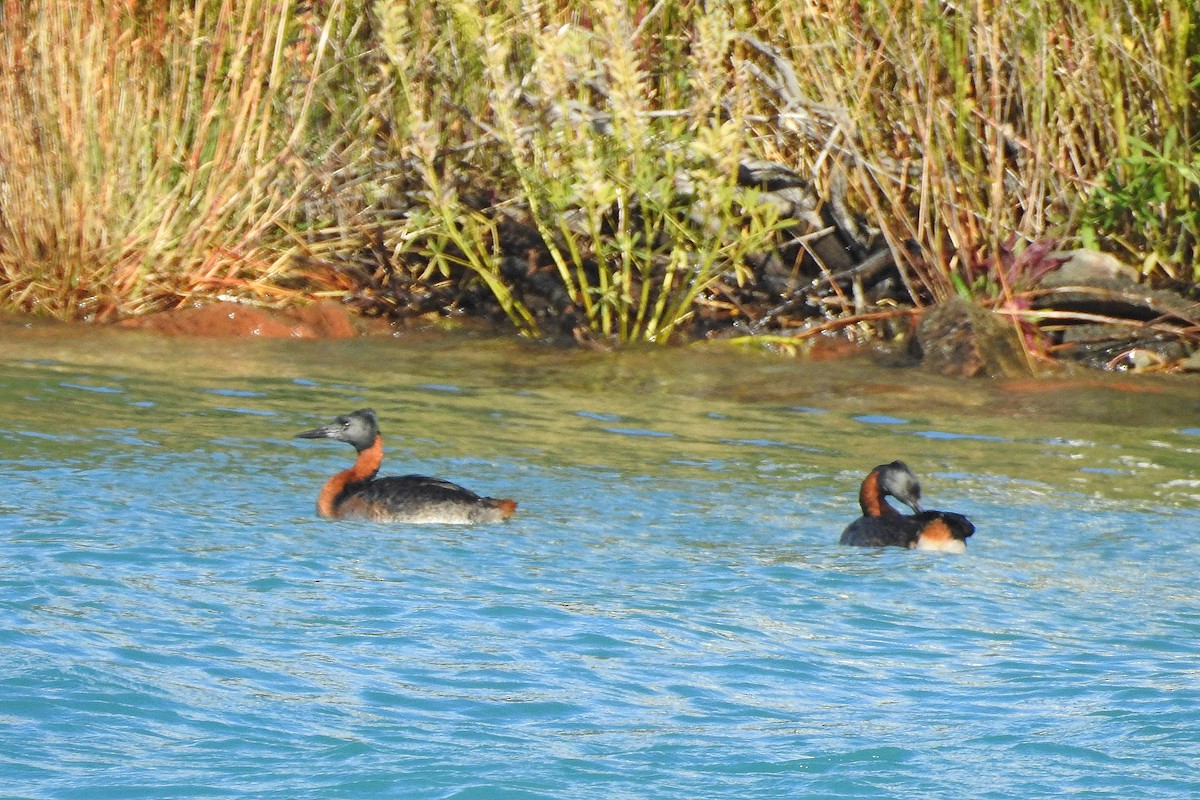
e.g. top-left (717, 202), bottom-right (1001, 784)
top-left (296, 408), bottom-right (517, 524)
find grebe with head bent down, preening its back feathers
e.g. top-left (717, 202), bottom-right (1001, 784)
top-left (841, 461), bottom-right (974, 553)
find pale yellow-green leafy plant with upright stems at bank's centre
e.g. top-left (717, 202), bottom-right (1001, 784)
top-left (377, 2), bottom-right (778, 343)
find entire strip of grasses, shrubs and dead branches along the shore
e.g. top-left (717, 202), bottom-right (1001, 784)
top-left (0, 0), bottom-right (1200, 367)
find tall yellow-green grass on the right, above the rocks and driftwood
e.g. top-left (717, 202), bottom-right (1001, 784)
top-left (767, 0), bottom-right (1200, 297)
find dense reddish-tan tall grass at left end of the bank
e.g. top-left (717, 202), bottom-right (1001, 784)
top-left (0, 0), bottom-right (341, 317)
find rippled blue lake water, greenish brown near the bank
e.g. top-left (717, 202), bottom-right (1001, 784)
top-left (0, 323), bottom-right (1200, 800)
